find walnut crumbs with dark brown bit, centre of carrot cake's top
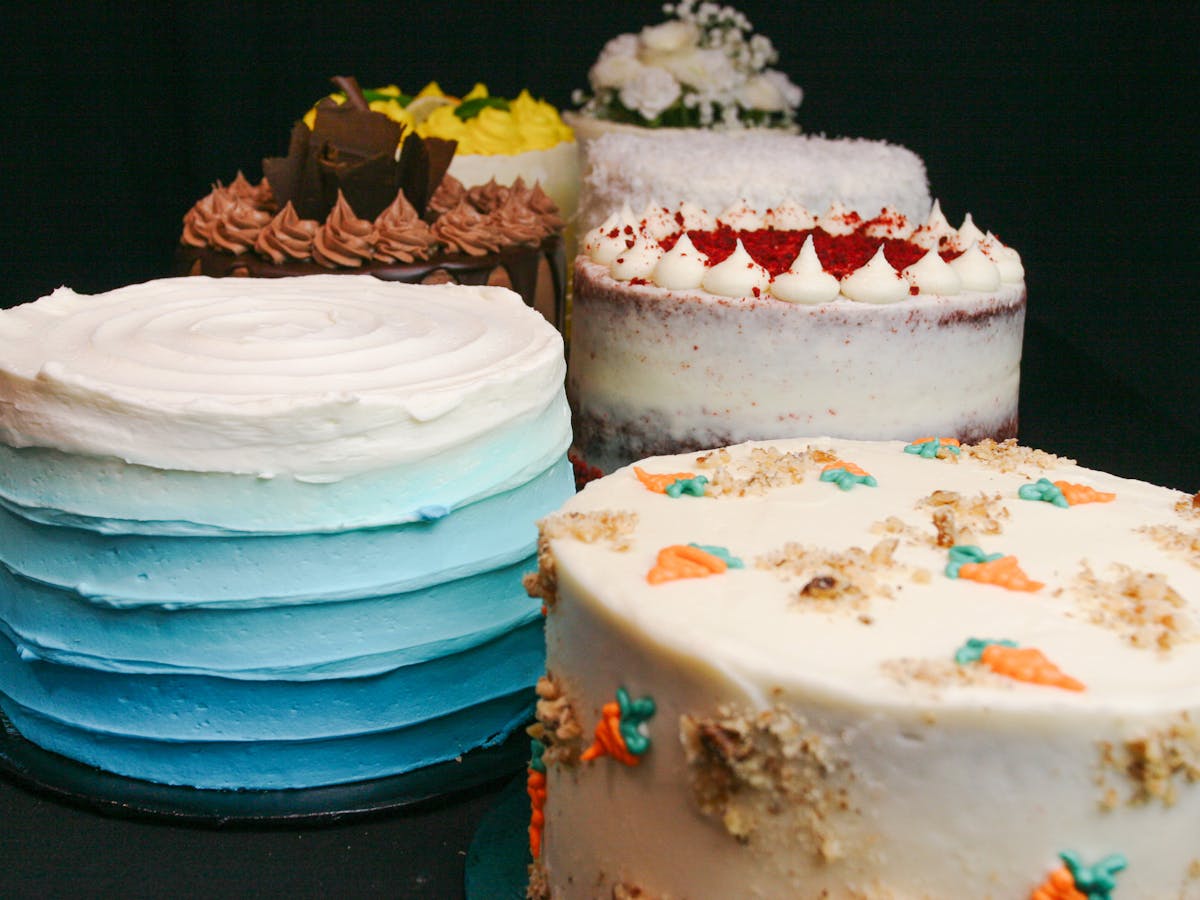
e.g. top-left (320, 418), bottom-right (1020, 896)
top-left (755, 538), bottom-right (901, 612)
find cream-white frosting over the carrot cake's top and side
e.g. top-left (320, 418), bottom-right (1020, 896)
top-left (542, 438), bottom-right (1200, 898)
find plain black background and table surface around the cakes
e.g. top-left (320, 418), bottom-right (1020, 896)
top-left (0, 0), bottom-right (1200, 896)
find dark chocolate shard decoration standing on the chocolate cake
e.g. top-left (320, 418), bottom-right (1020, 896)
top-left (263, 76), bottom-right (457, 221)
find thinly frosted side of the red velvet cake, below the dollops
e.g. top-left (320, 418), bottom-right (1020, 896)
top-left (566, 257), bottom-right (1025, 472)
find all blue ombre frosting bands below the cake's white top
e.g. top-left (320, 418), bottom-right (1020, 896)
top-left (0, 451), bottom-right (574, 788)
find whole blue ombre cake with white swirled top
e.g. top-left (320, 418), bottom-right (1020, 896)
top-left (0, 275), bottom-right (572, 788)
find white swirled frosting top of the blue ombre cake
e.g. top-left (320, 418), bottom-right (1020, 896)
top-left (0, 275), bottom-right (565, 481)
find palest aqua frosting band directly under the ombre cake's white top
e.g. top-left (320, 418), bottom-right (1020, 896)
top-left (0, 396), bottom-right (571, 535)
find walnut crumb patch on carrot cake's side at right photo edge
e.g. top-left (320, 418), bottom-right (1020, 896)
top-left (1097, 713), bottom-right (1200, 809)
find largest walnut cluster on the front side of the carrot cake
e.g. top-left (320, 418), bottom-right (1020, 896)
top-left (679, 707), bottom-right (862, 862)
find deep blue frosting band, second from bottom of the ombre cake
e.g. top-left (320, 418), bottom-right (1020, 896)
top-left (0, 616), bottom-right (545, 744)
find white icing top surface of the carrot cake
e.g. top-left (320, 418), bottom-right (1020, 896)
top-left (551, 438), bottom-right (1200, 716)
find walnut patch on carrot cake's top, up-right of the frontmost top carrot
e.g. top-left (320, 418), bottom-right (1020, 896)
top-left (1070, 563), bottom-right (1196, 653)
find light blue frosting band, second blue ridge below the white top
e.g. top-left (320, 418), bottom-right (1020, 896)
top-left (0, 460), bottom-right (575, 608)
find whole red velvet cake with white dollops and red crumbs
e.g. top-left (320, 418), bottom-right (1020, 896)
top-left (568, 204), bottom-right (1026, 472)
